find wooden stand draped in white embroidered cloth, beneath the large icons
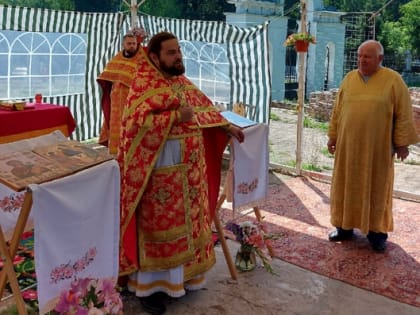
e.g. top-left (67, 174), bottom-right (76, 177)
top-left (0, 135), bottom-right (120, 315)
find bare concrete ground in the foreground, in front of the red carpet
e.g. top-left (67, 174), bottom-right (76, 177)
top-left (119, 232), bottom-right (420, 315)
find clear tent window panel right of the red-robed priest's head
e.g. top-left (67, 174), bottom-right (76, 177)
top-left (180, 41), bottom-right (230, 103)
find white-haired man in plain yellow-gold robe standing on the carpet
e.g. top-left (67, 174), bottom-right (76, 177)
top-left (328, 40), bottom-right (419, 252)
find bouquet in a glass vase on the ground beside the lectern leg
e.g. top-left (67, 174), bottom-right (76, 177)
top-left (226, 221), bottom-right (277, 273)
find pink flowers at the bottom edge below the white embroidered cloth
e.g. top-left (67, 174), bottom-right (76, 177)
top-left (52, 278), bottom-right (123, 315)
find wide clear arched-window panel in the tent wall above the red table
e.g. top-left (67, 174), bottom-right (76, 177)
top-left (0, 30), bottom-right (87, 99)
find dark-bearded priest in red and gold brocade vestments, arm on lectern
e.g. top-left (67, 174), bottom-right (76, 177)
top-left (117, 32), bottom-right (244, 314)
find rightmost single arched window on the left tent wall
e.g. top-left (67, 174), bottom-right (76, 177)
top-left (50, 34), bottom-right (87, 95)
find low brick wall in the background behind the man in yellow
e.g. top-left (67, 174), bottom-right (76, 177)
top-left (305, 88), bottom-right (420, 135)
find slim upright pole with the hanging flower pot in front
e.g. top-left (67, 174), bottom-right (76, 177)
top-left (296, 0), bottom-right (306, 176)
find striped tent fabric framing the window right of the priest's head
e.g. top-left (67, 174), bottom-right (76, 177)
top-left (136, 16), bottom-right (271, 123)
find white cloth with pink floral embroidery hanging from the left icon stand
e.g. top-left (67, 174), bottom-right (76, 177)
top-left (29, 160), bottom-right (120, 314)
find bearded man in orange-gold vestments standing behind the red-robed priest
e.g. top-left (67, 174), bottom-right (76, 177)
top-left (97, 33), bottom-right (141, 154)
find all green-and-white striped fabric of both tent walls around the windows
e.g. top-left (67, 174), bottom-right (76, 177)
top-left (0, 5), bottom-right (271, 140)
